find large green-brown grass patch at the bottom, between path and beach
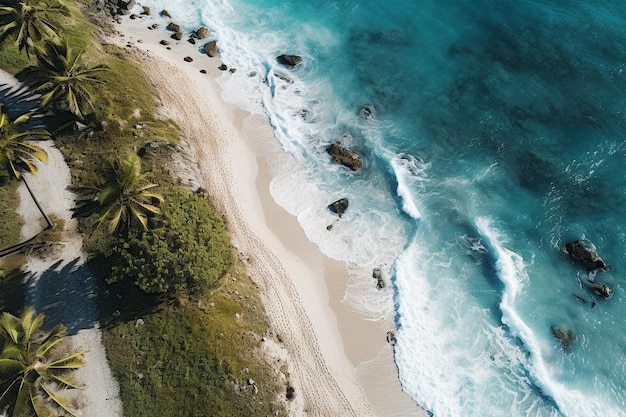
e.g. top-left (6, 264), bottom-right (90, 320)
top-left (104, 265), bottom-right (286, 417)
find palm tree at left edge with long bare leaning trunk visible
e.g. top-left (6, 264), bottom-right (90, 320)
top-left (0, 106), bottom-right (54, 228)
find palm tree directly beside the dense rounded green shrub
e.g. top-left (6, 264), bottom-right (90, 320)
top-left (75, 155), bottom-right (163, 233)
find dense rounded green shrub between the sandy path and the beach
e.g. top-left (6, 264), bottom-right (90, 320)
top-left (107, 188), bottom-right (231, 293)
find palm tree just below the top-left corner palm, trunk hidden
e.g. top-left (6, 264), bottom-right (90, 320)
top-left (20, 38), bottom-right (107, 120)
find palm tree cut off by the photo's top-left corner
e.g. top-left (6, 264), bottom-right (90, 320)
top-left (0, 0), bottom-right (69, 57)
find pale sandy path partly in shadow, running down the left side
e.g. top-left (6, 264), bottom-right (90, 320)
top-left (18, 141), bottom-right (123, 417)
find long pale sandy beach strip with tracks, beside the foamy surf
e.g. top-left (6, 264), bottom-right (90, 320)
top-left (114, 11), bottom-right (426, 417)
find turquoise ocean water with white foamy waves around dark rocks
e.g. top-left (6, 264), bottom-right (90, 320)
top-left (136, 0), bottom-right (626, 417)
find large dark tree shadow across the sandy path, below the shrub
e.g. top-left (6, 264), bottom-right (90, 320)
top-left (25, 258), bottom-right (161, 335)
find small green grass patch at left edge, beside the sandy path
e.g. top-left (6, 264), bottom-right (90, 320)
top-left (0, 177), bottom-right (24, 249)
